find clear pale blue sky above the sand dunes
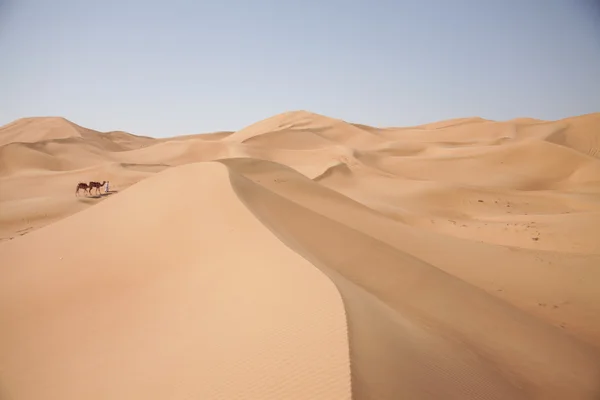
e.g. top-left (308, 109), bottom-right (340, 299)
top-left (0, 0), bottom-right (600, 137)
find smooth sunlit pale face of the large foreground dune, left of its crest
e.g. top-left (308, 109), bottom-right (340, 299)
top-left (0, 164), bottom-right (350, 399)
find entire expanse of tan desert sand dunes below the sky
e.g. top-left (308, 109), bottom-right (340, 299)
top-left (0, 111), bottom-right (600, 400)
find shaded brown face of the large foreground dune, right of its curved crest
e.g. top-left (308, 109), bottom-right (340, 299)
top-left (223, 160), bottom-right (600, 399)
